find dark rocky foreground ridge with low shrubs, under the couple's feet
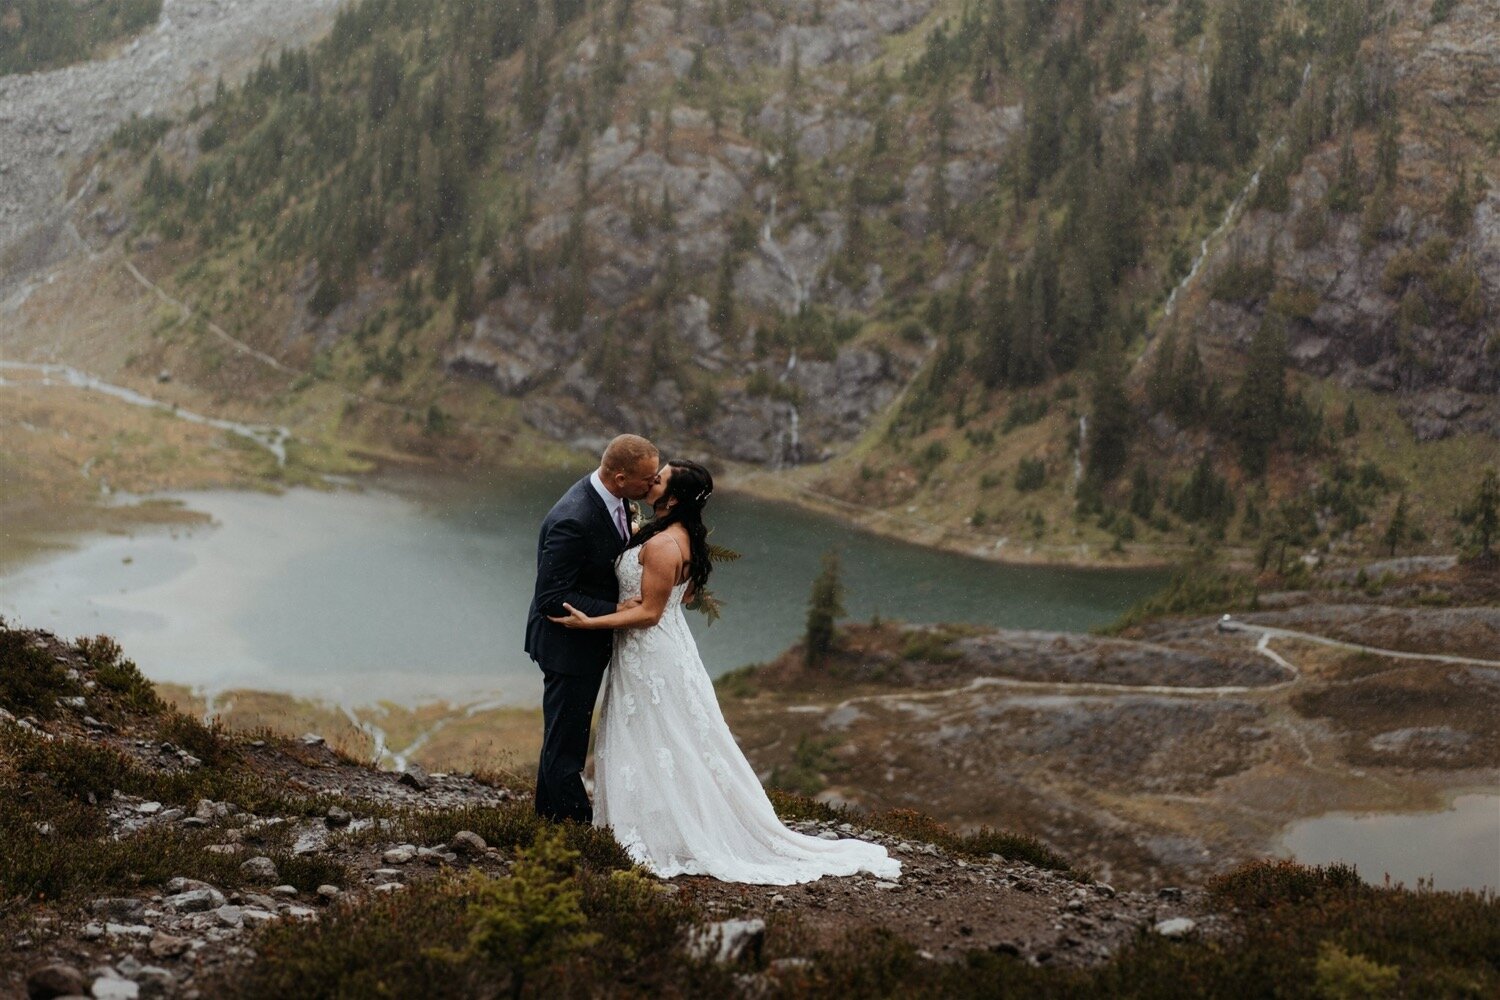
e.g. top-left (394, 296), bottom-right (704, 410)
top-left (0, 627), bottom-right (1500, 1000)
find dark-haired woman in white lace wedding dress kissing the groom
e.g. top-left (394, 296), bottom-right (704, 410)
top-left (552, 460), bottom-right (902, 886)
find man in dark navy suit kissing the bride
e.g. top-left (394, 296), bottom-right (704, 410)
top-left (527, 435), bottom-right (660, 823)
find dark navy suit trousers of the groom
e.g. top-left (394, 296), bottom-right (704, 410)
top-left (537, 670), bottom-right (605, 823)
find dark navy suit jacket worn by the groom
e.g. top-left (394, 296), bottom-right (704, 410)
top-left (527, 475), bottom-right (626, 676)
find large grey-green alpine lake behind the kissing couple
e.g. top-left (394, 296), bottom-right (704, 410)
top-left (0, 472), bottom-right (1166, 705)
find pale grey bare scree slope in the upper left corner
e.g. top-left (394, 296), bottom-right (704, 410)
top-left (0, 0), bottom-right (341, 292)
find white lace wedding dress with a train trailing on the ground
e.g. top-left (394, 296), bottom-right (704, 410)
top-left (594, 549), bottom-right (902, 886)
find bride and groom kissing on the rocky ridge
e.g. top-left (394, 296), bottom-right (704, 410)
top-left (525, 435), bottom-right (900, 885)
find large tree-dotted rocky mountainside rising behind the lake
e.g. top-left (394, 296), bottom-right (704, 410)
top-left (0, 0), bottom-right (1500, 562)
